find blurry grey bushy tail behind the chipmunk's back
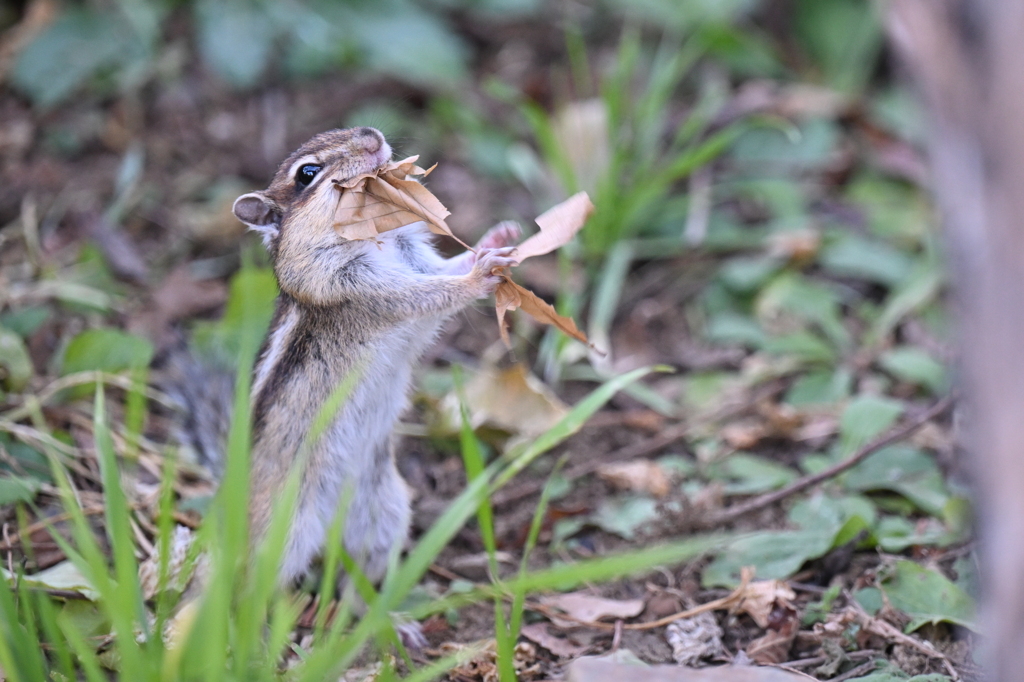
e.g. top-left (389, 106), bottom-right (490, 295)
top-left (155, 344), bottom-right (234, 480)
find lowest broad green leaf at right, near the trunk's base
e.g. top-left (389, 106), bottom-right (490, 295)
top-left (882, 561), bottom-right (978, 632)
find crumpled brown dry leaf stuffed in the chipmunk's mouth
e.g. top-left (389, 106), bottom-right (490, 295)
top-left (334, 157), bottom-right (469, 248)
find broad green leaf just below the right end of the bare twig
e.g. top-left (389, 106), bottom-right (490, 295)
top-left (842, 445), bottom-right (950, 517)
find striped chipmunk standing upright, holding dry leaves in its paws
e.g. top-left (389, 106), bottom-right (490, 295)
top-left (172, 128), bottom-right (519, 598)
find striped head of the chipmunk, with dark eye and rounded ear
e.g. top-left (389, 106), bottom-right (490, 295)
top-left (232, 128), bottom-right (391, 255)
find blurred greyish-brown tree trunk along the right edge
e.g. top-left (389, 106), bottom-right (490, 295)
top-left (887, 0), bottom-right (1024, 680)
